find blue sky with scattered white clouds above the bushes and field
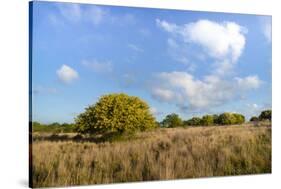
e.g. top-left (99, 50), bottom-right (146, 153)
top-left (31, 1), bottom-right (272, 123)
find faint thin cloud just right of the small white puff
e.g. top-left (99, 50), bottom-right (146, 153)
top-left (82, 60), bottom-right (113, 73)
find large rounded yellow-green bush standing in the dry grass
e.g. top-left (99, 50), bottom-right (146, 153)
top-left (75, 93), bottom-right (156, 133)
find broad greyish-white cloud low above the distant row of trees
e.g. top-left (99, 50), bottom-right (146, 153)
top-left (152, 72), bottom-right (233, 109)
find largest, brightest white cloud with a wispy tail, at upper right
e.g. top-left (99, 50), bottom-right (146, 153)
top-left (156, 19), bottom-right (247, 62)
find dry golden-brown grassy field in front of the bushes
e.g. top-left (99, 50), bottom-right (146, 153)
top-left (32, 125), bottom-right (271, 187)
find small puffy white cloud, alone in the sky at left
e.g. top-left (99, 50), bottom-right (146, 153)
top-left (57, 64), bottom-right (79, 84)
